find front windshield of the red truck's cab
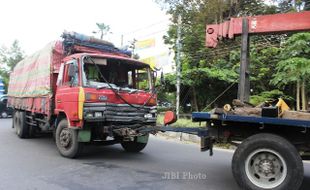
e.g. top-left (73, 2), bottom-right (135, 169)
top-left (82, 57), bottom-right (152, 91)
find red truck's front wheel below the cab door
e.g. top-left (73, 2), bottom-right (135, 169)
top-left (56, 119), bottom-right (83, 158)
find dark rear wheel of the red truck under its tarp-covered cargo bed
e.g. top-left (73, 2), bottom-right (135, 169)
top-left (14, 111), bottom-right (29, 139)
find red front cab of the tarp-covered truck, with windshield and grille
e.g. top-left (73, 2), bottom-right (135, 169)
top-left (54, 53), bottom-right (157, 157)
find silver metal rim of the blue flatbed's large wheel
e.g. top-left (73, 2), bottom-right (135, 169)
top-left (245, 149), bottom-right (287, 189)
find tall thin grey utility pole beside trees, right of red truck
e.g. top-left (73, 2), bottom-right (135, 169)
top-left (176, 15), bottom-right (182, 118)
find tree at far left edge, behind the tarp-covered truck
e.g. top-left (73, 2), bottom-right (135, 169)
top-left (0, 40), bottom-right (25, 92)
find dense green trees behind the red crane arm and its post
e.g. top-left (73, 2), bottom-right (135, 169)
top-left (157, 0), bottom-right (310, 110)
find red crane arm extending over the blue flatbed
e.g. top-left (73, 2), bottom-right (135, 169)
top-left (206, 11), bottom-right (310, 48)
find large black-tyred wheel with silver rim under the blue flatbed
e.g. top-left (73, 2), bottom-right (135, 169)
top-left (232, 134), bottom-right (304, 190)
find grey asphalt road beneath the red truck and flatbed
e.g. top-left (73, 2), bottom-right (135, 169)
top-left (0, 119), bottom-right (310, 190)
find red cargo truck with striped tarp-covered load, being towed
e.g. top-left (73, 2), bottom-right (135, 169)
top-left (8, 32), bottom-right (157, 158)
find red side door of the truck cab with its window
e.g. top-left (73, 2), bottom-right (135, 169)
top-left (55, 59), bottom-right (80, 123)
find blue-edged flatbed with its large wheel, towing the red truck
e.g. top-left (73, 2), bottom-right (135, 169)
top-left (192, 112), bottom-right (310, 190)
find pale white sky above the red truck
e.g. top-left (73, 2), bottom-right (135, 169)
top-left (0, 0), bottom-right (169, 55)
